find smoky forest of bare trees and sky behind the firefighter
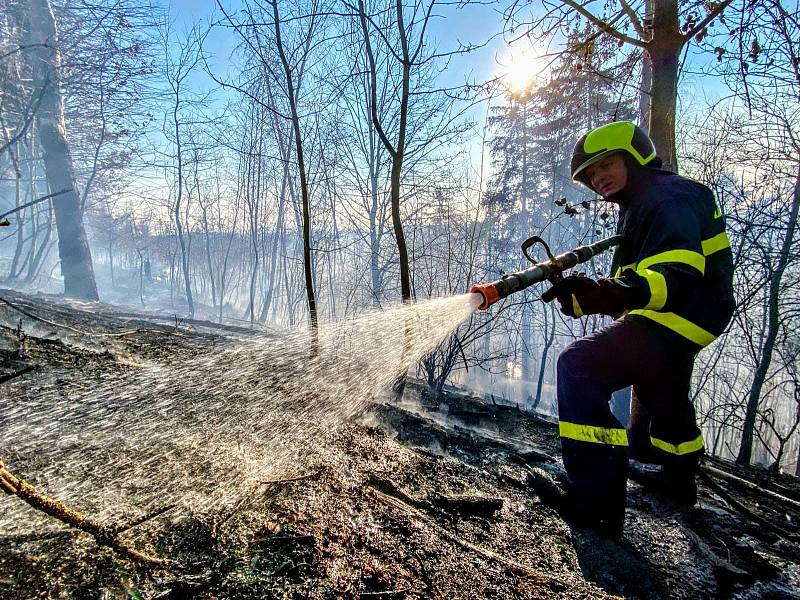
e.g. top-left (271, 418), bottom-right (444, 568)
top-left (0, 0), bottom-right (800, 597)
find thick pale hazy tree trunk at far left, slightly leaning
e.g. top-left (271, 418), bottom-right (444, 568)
top-left (30, 0), bottom-right (98, 300)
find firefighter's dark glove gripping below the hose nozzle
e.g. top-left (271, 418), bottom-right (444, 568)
top-left (542, 274), bottom-right (625, 319)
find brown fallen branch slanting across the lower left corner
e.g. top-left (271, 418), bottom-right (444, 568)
top-left (0, 460), bottom-right (171, 566)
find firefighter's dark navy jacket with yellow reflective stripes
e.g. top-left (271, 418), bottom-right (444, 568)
top-left (610, 169), bottom-right (734, 347)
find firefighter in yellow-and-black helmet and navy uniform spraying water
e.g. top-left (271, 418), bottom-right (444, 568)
top-left (542, 121), bottom-right (734, 535)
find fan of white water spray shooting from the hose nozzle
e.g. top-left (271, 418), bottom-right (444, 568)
top-left (0, 294), bottom-right (478, 541)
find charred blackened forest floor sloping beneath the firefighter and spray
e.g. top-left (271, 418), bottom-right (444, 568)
top-left (0, 291), bottom-right (800, 599)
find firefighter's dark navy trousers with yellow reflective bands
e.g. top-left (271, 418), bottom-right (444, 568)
top-left (557, 315), bottom-right (703, 515)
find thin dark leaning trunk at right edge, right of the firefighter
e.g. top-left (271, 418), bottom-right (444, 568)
top-left (736, 165), bottom-right (800, 465)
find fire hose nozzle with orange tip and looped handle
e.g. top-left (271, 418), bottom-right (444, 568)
top-left (469, 235), bottom-right (624, 310)
